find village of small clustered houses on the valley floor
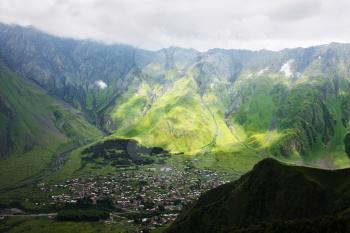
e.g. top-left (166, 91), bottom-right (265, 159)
top-left (38, 166), bottom-right (232, 232)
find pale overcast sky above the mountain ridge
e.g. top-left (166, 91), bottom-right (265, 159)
top-left (0, 0), bottom-right (350, 50)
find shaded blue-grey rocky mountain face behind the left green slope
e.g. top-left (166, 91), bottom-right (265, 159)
top-left (0, 24), bottom-right (152, 129)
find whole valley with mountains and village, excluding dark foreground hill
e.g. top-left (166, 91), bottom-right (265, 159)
top-left (0, 23), bottom-right (350, 232)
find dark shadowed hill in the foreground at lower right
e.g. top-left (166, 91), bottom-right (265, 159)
top-left (166, 159), bottom-right (350, 233)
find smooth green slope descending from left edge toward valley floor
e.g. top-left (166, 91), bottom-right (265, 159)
top-left (0, 63), bottom-right (102, 193)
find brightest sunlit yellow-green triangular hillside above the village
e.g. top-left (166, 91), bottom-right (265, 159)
top-left (112, 77), bottom-right (239, 153)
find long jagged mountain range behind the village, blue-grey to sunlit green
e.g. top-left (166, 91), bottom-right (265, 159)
top-left (0, 24), bottom-right (350, 169)
